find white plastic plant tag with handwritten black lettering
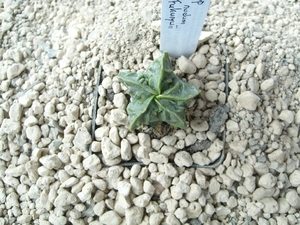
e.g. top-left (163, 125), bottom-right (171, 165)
top-left (160, 0), bottom-right (210, 58)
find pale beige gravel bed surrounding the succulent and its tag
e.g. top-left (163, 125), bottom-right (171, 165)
top-left (0, 0), bottom-right (300, 225)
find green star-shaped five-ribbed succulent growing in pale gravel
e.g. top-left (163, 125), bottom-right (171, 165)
top-left (118, 52), bottom-right (200, 130)
